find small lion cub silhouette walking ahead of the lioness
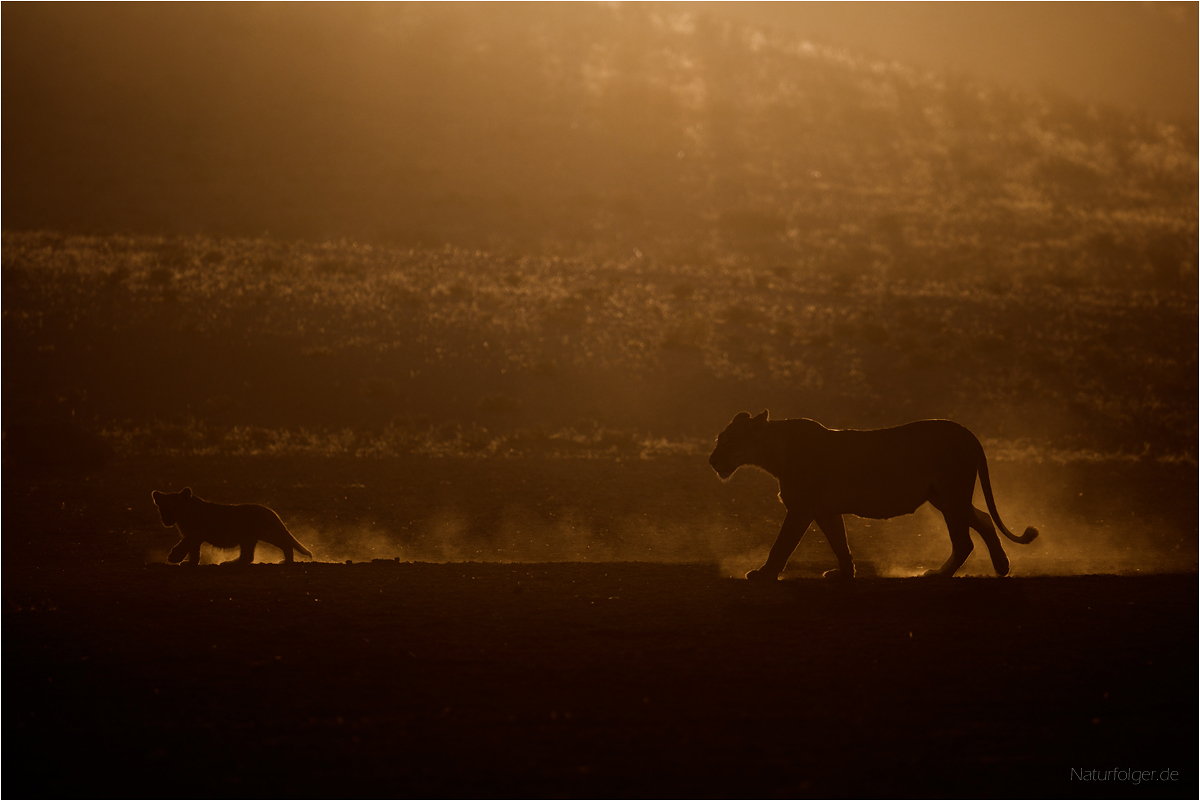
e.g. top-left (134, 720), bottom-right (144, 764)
top-left (150, 487), bottom-right (312, 566)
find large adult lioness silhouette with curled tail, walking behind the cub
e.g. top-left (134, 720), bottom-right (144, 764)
top-left (708, 410), bottom-right (1038, 579)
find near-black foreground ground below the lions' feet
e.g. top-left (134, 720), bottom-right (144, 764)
top-left (4, 560), bottom-right (1198, 797)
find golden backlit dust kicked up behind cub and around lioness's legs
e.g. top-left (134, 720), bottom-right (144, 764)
top-left (201, 491), bottom-right (1196, 578)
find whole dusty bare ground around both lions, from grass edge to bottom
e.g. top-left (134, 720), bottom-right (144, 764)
top-left (4, 459), bottom-right (1198, 797)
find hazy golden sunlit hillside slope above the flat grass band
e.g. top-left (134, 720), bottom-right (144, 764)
top-left (4, 5), bottom-right (1198, 293)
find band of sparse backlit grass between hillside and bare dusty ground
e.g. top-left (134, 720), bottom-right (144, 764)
top-left (2, 227), bottom-right (1196, 459)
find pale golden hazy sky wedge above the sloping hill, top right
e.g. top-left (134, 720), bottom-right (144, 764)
top-left (710, 2), bottom-right (1200, 122)
